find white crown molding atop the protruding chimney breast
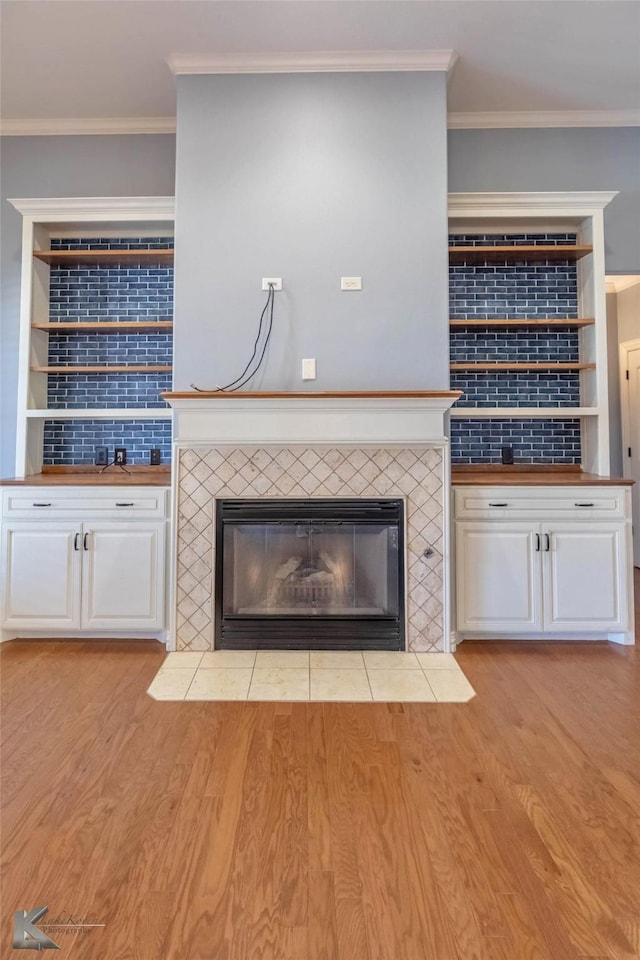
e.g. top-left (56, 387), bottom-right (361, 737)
top-left (167, 50), bottom-right (458, 76)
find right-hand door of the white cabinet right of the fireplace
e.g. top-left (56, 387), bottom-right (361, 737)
top-left (544, 522), bottom-right (627, 632)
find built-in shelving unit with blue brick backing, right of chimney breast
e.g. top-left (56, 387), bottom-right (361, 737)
top-left (449, 193), bottom-right (615, 475)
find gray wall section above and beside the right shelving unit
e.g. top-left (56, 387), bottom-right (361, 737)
top-left (449, 127), bottom-right (640, 274)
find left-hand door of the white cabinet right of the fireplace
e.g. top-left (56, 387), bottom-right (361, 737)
top-left (456, 521), bottom-right (542, 633)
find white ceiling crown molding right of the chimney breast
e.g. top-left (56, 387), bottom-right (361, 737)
top-left (447, 110), bottom-right (640, 130)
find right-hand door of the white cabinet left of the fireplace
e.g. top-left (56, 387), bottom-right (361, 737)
top-left (82, 521), bottom-right (164, 633)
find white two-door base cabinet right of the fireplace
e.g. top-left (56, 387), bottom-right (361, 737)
top-left (454, 487), bottom-right (633, 643)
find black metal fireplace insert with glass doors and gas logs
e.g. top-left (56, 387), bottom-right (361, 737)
top-left (215, 498), bottom-right (405, 650)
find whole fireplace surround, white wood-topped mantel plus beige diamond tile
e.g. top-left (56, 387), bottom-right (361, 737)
top-left (164, 391), bottom-right (459, 652)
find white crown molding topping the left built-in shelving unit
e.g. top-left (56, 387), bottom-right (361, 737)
top-left (9, 197), bottom-right (175, 223)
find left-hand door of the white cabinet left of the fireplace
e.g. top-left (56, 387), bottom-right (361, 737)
top-left (2, 522), bottom-right (82, 630)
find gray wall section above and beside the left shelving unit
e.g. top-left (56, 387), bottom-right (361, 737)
top-left (0, 135), bottom-right (175, 477)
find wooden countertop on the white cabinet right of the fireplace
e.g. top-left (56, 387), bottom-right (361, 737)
top-left (451, 465), bottom-right (633, 487)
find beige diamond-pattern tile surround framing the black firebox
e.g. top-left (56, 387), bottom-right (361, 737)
top-left (176, 445), bottom-right (445, 652)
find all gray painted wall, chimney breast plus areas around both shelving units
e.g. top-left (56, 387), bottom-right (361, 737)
top-left (0, 123), bottom-right (640, 476)
